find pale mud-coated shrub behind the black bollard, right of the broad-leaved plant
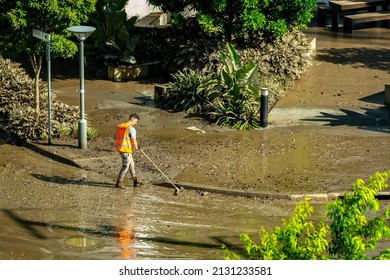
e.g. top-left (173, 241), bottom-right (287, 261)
top-left (203, 31), bottom-right (311, 110)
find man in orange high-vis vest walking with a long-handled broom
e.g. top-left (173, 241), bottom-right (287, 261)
top-left (114, 113), bottom-right (142, 189)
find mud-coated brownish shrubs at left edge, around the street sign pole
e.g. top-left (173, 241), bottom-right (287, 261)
top-left (0, 57), bottom-right (97, 142)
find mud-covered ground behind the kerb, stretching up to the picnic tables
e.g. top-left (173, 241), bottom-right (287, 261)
top-left (3, 23), bottom-right (390, 196)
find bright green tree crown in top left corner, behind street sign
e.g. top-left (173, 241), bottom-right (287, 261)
top-left (0, 0), bottom-right (96, 58)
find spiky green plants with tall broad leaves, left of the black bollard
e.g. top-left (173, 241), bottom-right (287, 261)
top-left (164, 43), bottom-right (260, 130)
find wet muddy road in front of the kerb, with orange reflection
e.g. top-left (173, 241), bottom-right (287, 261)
top-left (0, 145), bottom-right (322, 259)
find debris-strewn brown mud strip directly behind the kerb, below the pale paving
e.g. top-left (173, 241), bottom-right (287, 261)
top-left (29, 119), bottom-right (389, 196)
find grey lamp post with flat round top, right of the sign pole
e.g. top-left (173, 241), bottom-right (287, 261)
top-left (67, 25), bottom-right (96, 149)
